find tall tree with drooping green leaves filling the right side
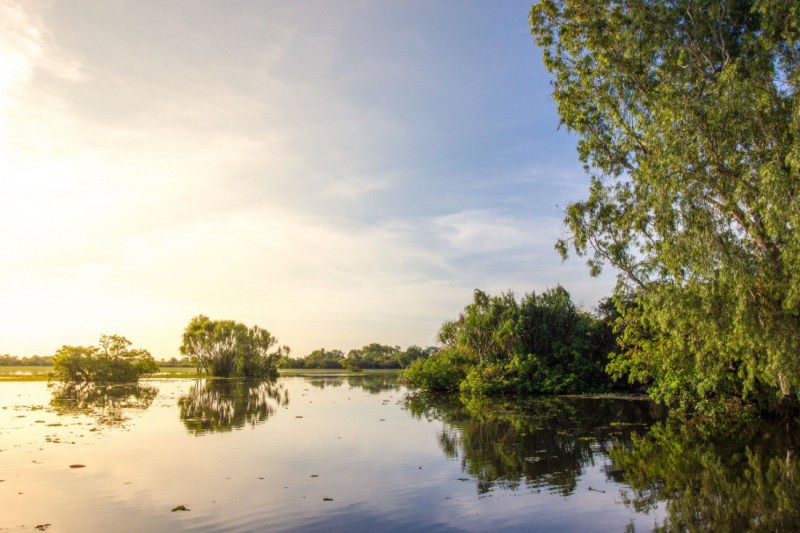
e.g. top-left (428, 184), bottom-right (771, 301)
top-left (530, 0), bottom-right (800, 406)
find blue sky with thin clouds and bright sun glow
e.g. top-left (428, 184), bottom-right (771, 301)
top-left (0, 0), bottom-right (614, 359)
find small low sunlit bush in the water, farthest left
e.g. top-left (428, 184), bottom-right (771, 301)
top-left (51, 335), bottom-right (158, 383)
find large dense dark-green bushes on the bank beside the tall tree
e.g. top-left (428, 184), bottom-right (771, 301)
top-left (404, 287), bottom-right (613, 395)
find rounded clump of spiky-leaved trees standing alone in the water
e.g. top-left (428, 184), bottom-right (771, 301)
top-left (181, 315), bottom-right (289, 378)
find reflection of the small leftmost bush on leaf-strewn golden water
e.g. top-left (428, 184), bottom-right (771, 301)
top-left (50, 382), bottom-right (158, 426)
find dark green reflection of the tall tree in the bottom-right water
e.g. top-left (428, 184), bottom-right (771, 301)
top-left (611, 422), bottom-right (800, 531)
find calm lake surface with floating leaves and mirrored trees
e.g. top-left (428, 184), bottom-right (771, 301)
top-left (0, 374), bottom-right (800, 531)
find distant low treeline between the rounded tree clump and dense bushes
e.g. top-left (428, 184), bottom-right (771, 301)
top-left (278, 343), bottom-right (437, 370)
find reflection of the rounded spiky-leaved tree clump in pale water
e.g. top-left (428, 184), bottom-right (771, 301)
top-left (178, 379), bottom-right (289, 435)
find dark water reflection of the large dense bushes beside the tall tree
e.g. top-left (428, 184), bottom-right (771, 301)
top-left (406, 395), bottom-right (663, 496)
